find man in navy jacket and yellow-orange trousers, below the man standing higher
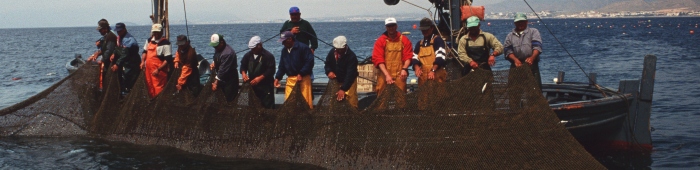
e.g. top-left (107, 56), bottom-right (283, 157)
top-left (274, 31), bottom-right (314, 109)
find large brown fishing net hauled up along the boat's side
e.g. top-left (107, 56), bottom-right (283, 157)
top-left (0, 64), bottom-right (604, 169)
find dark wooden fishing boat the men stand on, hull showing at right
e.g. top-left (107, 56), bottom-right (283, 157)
top-left (275, 0), bottom-right (656, 153)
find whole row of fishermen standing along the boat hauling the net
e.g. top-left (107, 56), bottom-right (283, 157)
top-left (88, 7), bottom-right (542, 108)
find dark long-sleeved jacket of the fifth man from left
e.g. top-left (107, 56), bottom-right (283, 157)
top-left (214, 44), bottom-right (238, 84)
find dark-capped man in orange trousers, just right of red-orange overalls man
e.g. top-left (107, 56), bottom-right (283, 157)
top-left (173, 35), bottom-right (202, 96)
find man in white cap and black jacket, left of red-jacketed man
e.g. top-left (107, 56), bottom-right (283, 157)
top-left (324, 36), bottom-right (359, 108)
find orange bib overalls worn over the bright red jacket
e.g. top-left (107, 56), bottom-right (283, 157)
top-left (376, 35), bottom-right (406, 95)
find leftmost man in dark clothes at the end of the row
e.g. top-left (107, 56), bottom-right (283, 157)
top-left (88, 19), bottom-right (117, 91)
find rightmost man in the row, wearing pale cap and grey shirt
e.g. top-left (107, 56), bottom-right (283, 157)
top-left (504, 13), bottom-right (542, 89)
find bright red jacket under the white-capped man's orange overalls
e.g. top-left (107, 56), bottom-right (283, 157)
top-left (372, 31), bottom-right (413, 67)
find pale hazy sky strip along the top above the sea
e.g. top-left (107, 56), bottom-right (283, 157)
top-left (0, 0), bottom-right (503, 28)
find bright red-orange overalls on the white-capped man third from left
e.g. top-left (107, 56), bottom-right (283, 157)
top-left (145, 42), bottom-right (168, 98)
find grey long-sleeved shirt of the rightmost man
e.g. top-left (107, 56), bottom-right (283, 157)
top-left (503, 28), bottom-right (542, 60)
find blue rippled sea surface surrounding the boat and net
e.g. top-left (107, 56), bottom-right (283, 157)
top-left (0, 18), bottom-right (700, 169)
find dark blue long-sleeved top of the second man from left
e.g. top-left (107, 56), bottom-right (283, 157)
top-left (115, 32), bottom-right (141, 67)
